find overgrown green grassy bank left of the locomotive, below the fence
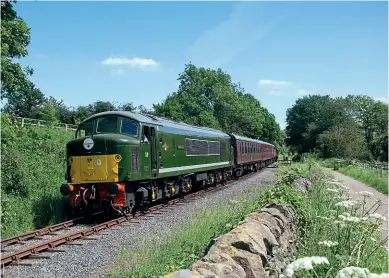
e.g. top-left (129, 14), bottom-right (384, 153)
top-left (1, 114), bottom-right (73, 238)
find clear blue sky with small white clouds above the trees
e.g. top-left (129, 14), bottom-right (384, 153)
top-left (15, 2), bottom-right (388, 127)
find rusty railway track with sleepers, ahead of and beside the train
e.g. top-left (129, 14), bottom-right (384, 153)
top-left (0, 165), bottom-right (270, 268)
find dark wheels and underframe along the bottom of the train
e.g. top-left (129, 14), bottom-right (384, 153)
top-left (68, 158), bottom-right (276, 216)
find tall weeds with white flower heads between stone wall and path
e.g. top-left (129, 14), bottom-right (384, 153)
top-left (284, 168), bottom-right (388, 277)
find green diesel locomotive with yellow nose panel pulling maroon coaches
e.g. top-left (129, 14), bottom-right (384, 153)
top-left (60, 111), bottom-right (278, 215)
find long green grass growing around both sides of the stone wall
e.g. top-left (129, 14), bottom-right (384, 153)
top-left (109, 165), bottom-right (388, 277)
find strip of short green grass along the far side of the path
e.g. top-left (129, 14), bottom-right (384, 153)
top-left (337, 165), bottom-right (388, 194)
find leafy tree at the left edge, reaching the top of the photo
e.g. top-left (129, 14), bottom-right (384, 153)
top-left (1, 1), bottom-right (45, 117)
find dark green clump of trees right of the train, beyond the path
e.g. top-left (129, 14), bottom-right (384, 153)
top-left (286, 95), bottom-right (388, 161)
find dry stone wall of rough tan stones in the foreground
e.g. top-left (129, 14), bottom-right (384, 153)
top-left (163, 204), bottom-right (297, 278)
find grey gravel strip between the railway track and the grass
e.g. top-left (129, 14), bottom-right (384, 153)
top-left (2, 168), bottom-right (277, 278)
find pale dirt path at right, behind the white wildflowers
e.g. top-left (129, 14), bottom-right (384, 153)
top-left (330, 170), bottom-right (388, 239)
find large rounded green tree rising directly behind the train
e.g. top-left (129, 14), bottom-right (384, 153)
top-left (154, 64), bottom-right (281, 143)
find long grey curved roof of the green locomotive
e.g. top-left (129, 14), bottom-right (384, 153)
top-left (82, 111), bottom-right (229, 138)
